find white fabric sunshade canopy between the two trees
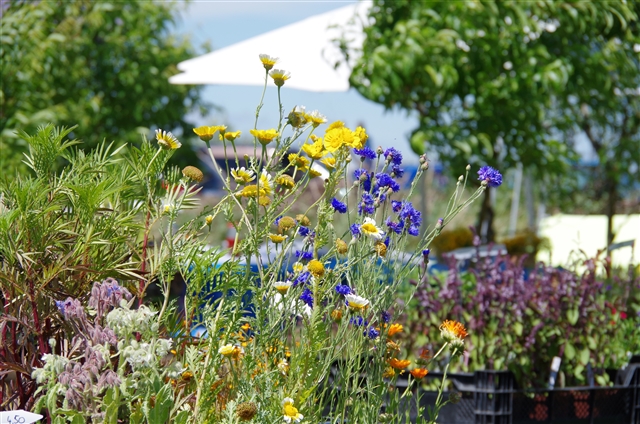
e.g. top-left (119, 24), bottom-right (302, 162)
top-left (169, 2), bottom-right (371, 92)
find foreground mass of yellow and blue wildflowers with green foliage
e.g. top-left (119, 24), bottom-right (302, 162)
top-left (0, 55), bottom-right (502, 423)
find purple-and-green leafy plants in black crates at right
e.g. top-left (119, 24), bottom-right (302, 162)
top-left (404, 247), bottom-right (640, 388)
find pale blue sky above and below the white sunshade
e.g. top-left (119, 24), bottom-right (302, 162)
top-left (177, 0), bottom-right (418, 160)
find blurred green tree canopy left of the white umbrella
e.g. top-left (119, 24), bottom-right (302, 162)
top-left (0, 0), bottom-right (204, 172)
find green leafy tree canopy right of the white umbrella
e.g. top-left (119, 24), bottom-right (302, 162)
top-left (351, 0), bottom-right (640, 242)
